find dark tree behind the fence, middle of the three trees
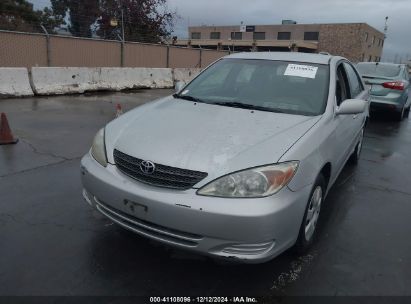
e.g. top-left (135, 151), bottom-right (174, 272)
top-left (51, 0), bottom-right (100, 37)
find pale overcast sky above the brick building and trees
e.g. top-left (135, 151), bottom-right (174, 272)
top-left (30, 0), bottom-right (411, 61)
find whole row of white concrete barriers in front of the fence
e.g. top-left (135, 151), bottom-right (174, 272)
top-left (0, 67), bottom-right (206, 97)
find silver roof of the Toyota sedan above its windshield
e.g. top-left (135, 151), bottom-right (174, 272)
top-left (224, 52), bottom-right (334, 64)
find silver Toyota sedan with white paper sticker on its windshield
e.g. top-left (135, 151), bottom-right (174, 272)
top-left (81, 53), bottom-right (369, 263)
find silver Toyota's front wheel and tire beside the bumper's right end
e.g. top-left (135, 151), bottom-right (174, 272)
top-left (294, 174), bottom-right (326, 255)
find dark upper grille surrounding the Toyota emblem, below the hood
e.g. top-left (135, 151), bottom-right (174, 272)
top-left (114, 150), bottom-right (207, 190)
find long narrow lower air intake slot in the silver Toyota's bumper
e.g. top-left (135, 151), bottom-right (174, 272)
top-left (94, 198), bottom-right (203, 247)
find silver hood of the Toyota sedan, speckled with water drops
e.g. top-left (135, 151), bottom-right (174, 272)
top-left (106, 97), bottom-right (320, 187)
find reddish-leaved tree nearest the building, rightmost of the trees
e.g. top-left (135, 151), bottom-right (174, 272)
top-left (97, 0), bottom-right (178, 43)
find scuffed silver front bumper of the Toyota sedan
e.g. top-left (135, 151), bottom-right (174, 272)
top-left (81, 153), bottom-right (311, 263)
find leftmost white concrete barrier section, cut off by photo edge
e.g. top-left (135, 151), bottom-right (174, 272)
top-left (0, 68), bottom-right (33, 97)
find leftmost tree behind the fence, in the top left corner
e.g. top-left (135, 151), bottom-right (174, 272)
top-left (0, 0), bottom-right (63, 32)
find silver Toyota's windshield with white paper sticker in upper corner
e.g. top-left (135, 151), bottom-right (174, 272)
top-left (177, 59), bottom-right (329, 115)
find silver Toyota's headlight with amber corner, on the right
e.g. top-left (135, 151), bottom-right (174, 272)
top-left (197, 161), bottom-right (298, 198)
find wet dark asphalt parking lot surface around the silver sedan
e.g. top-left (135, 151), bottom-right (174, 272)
top-left (0, 90), bottom-right (411, 297)
